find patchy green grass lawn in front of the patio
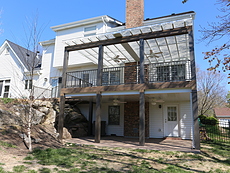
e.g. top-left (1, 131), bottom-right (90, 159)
top-left (0, 143), bottom-right (230, 173)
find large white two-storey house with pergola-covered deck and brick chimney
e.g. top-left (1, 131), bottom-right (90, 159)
top-left (41, 0), bottom-right (200, 149)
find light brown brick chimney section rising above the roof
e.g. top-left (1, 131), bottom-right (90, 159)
top-left (126, 0), bottom-right (144, 28)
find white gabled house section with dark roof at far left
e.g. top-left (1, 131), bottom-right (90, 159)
top-left (0, 40), bottom-right (50, 98)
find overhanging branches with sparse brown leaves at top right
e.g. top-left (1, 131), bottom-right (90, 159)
top-left (200, 0), bottom-right (230, 78)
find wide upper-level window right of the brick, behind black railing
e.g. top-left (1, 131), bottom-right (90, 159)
top-left (157, 64), bottom-right (185, 82)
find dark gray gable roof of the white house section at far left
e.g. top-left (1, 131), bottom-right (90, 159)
top-left (6, 40), bottom-right (41, 71)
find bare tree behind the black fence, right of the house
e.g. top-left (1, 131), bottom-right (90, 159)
top-left (197, 69), bottom-right (227, 115)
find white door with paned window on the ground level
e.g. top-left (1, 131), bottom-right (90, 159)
top-left (164, 105), bottom-right (179, 137)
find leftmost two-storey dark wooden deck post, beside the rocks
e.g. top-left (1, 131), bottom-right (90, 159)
top-left (58, 50), bottom-right (69, 141)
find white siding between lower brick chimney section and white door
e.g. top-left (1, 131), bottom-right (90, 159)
top-left (149, 104), bottom-right (164, 138)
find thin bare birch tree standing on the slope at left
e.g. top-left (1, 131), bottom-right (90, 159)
top-left (14, 16), bottom-right (47, 151)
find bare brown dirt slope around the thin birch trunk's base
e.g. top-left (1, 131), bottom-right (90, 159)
top-left (0, 125), bottom-right (63, 171)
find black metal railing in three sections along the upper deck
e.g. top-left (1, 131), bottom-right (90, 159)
top-left (66, 61), bottom-right (191, 88)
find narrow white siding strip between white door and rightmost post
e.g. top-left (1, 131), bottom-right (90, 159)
top-left (179, 102), bottom-right (193, 139)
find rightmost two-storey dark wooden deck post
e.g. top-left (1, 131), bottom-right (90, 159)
top-left (188, 29), bottom-right (200, 150)
